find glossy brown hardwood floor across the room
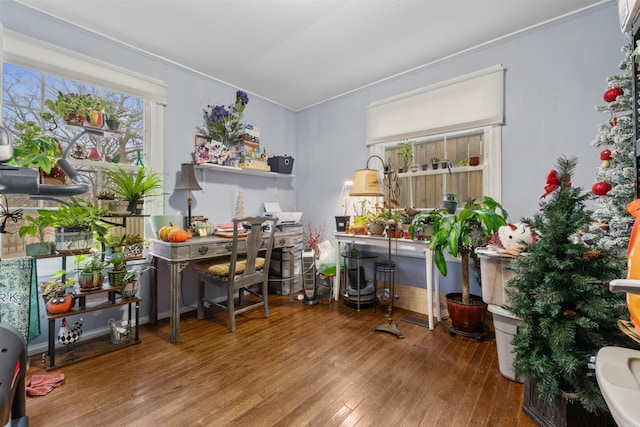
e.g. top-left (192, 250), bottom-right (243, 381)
top-left (27, 295), bottom-right (534, 427)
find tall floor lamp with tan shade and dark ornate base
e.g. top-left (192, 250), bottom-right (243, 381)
top-left (349, 155), bottom-right (404, 338)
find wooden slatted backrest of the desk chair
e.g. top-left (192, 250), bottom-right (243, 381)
top-left (229, 216), bottom-right (278, 287)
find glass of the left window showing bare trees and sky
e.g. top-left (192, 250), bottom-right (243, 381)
top-left (0, 63), bottom-right (144, 254)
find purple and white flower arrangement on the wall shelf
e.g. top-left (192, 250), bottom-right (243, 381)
top-left (198, 90), bottom-right (249, 147)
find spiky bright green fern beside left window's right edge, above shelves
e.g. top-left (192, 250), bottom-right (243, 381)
top-left (106, 166), bottom-right (162, 214)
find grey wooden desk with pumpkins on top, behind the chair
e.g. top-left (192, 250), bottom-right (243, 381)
top-left (149, 232), bottom-right (295, 344)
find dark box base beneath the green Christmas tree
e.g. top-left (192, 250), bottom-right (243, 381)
top-left (522, 379), bottom-right (616, 427)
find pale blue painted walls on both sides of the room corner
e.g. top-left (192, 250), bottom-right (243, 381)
top-left (0, 1), bottom-right (627, 344)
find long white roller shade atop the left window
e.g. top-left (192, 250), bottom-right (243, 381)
top-left (2, 30), bottom-right (167, 105)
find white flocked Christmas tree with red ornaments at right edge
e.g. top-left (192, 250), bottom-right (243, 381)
top-left (588, 44), bottom-right (635, 255)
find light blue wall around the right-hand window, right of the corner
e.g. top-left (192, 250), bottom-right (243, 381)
top-left (296, 2), bottom-right (628, 292)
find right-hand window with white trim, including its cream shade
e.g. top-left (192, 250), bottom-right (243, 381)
top-left (367, 65), bottom-right (504, 209)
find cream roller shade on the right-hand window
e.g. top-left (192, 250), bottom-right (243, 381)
top-left (367, 65), bottom-right (504, 145)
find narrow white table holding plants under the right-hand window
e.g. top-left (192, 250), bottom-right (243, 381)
top-left (333, 233), bottom-right (442, 330)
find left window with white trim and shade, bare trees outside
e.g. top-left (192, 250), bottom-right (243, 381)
top-left (0, 26), bottom-right (167, 253)
